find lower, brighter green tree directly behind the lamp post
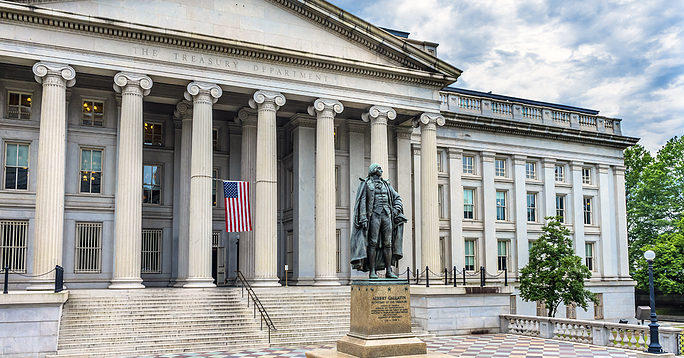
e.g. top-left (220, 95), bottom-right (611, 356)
top-left (634, 219), bottom-right (684, 295)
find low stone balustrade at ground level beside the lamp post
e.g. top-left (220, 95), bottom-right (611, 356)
top-left (499, 315), bottom-right (682, 352)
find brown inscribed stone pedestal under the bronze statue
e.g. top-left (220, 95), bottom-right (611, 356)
top-left (306, 279), bottom-right (448, 358)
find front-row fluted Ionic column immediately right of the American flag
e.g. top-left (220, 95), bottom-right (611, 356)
top-left (249, 91), bottom-right (285, 286)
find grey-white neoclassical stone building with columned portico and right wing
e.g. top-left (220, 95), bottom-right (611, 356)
top-left (0, 0), bottom-right (636, 318)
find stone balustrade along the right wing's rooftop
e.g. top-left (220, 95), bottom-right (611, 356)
top-left (439, 91), bottom-right (622, 135)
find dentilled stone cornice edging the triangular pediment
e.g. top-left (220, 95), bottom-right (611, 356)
top-left (0, 0), bottom-right (461, 88)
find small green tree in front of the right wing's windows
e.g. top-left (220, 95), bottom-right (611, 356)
top-left (520, 216), bottom-right (598, 317)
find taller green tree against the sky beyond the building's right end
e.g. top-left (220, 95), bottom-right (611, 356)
top-left (624, 137), bottom-right (684, 272)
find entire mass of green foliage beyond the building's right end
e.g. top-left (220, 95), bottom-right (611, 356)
top-left (625, 137), bottom-right (684, 293)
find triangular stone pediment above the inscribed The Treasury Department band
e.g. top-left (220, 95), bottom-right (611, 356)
top-left (8, 0), bottom-right (461, 83)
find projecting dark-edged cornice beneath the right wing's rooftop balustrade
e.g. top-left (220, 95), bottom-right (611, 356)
top-left (442, 112), bottom-right (639, 149)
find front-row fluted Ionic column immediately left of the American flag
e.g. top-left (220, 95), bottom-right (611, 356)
top-left (183, 82), bottom-right (223, 288)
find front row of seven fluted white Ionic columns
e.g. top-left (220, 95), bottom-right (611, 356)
top-left (29, 62), bottom-right (452, 290)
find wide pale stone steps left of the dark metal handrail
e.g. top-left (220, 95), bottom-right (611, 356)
top-left (50, 288), bottom-right (268, 357)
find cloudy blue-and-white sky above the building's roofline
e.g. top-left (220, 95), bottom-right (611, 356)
top-left (331, 0), bottom-right (684, 154)
